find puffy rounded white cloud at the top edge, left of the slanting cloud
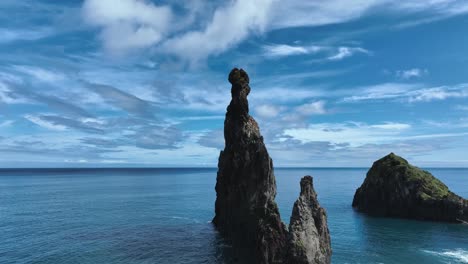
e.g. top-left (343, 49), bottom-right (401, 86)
top-left (83, 0), bottom-right (172, 54)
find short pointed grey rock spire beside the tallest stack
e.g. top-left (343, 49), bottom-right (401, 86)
top-left (289, 176), bottom-right (332, 264)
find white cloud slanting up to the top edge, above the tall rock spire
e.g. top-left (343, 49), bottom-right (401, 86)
top-left (163, 0), bottom-right (273, 63)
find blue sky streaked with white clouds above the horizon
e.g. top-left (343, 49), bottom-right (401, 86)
top-left (0, 0), bottom-right (468, 167)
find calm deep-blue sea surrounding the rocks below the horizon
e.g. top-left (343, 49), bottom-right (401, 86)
top-left (0, 168), bottom-right (468, 264)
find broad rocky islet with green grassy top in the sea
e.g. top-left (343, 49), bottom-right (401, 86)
top-left (353, 153), bottom-right (468, 223)
